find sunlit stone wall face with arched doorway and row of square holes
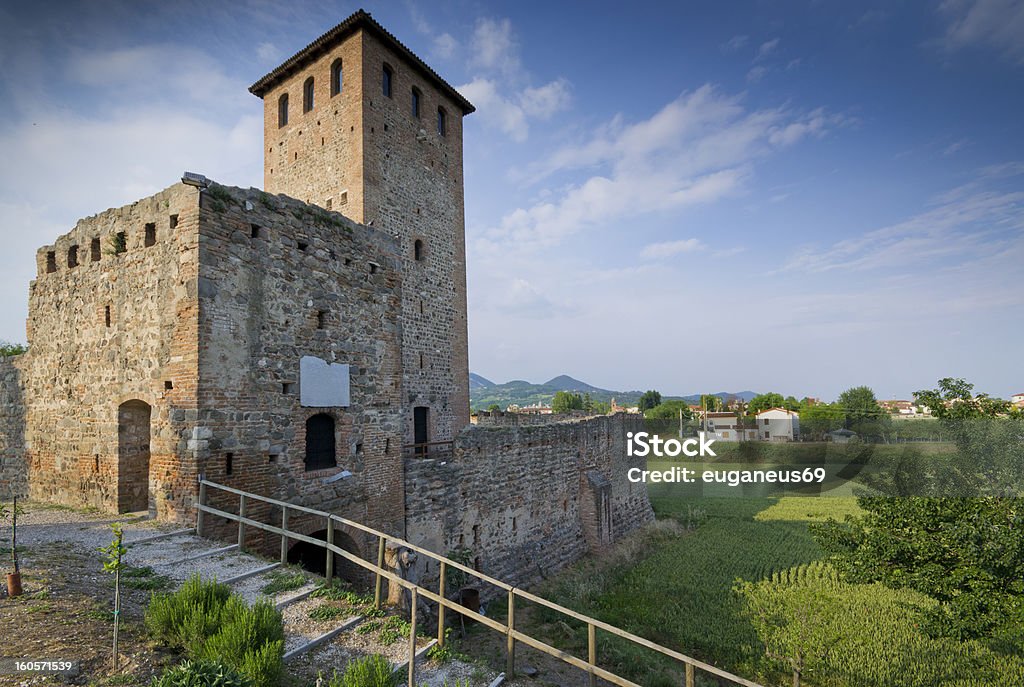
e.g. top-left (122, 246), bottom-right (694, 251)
top-left (23, 184), bottom-right (199, 518)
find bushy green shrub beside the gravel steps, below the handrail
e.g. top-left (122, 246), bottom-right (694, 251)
top-left (145, 575), bottom-right (285, 687)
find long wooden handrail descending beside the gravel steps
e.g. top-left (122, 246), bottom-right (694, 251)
top-left (196, 479), bottom-right (763, 687)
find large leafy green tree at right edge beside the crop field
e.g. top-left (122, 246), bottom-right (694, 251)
top-left (812, 378), bottom-right (1024, 642)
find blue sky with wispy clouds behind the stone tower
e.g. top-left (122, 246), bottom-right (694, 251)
top-left (0, 0), bottom-right (1024, 398)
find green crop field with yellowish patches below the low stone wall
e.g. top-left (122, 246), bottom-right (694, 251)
top-left (542, 487), bottom-right (1024, 687)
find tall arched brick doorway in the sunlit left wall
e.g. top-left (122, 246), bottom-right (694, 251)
top-left (118, 400), bottom-right (153, 513)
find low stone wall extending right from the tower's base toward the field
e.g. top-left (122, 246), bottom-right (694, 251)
top-left (406, 415), bottom-right (653, 586)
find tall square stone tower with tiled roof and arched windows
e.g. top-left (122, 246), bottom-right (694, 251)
top-left (250, 10), bottom-right (474, 444)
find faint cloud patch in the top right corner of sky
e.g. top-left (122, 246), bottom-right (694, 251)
top-left (940, 0), bottom-right (1024, 65)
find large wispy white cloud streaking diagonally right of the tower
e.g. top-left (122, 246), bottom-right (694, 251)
top-left (480, 85), bottom-right (843, 250)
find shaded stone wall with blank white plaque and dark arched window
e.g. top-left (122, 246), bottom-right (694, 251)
top-left (192, 186), bottom-right (404, 544)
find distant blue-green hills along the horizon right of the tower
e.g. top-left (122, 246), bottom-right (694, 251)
top-left (469, 373), bottom-right (757, 411)
